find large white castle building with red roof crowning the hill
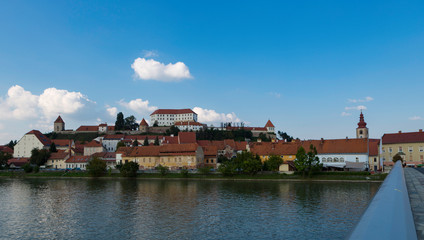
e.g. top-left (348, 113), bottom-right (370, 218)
top-left (150, 108), bottom-right (197, 126)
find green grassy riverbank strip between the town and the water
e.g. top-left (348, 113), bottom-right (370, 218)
top-left (0, 171), bottom-right (387, 182)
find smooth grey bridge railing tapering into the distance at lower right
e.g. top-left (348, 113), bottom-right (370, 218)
top-left (348, 161), bottom-right (417, 240)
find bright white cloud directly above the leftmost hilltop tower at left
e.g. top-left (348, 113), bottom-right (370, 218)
top-left (38, 88), bottom-right (90, 119)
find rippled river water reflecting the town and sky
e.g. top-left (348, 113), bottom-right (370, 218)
top-left (0, 179), bottom-right (380, 239)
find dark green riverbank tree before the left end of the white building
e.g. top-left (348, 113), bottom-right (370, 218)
top-left (294, 144), bottom-right (322, 177)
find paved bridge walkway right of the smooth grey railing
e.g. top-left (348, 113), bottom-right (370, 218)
top-left (404, 168), bottom-right (424, 240)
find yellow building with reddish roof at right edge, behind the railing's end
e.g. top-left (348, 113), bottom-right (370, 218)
top-left (381, 129), bottom-right (424, 166)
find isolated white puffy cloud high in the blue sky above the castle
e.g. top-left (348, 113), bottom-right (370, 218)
top-left (131, 58), bottom-right (192, 82)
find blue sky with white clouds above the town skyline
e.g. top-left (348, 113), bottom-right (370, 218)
top-left (0, 1), bottom-right (424, 143)
